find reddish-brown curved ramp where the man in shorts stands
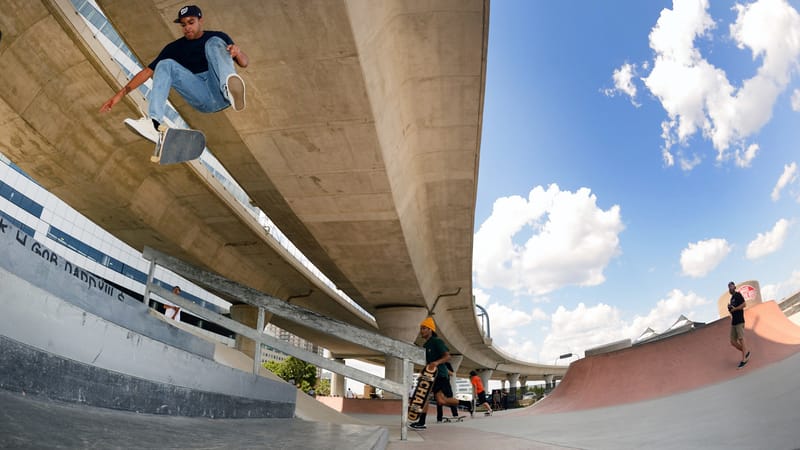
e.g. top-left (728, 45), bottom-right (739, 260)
top-left (531, 301), bottom-right (800, 414)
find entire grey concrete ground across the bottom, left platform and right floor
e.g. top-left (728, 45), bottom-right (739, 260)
top-left (0, 353), bottom-right (800, 450)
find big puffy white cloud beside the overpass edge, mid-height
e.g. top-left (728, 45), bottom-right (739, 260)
top-left (473, 184), bottom-right (624, 295)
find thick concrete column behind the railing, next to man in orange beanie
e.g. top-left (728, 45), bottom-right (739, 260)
top-left (374, 306), bottom-right (428, 398)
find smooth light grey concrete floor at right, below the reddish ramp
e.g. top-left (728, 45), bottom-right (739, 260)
top-left (388, 353), bottom-right (800, 450)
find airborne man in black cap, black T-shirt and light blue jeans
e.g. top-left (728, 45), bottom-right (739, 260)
top-left (100, 5), bottom-right (249, 143)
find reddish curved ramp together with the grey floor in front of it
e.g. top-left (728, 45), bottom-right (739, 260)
top-left (389, 302), bottom-right (800, 450)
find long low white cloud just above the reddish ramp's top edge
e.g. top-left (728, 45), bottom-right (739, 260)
top-left (539, 289), bottom-right (714, 364)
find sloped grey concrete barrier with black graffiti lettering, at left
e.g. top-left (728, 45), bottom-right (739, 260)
top-left (0, 218), bottom-right (296, 417)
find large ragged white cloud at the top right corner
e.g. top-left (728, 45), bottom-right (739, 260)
top-left (643, 0), bottom-right (800, 170)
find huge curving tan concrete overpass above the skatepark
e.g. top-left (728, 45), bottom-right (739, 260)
top-left (0, 0), bottom-right (565, 379)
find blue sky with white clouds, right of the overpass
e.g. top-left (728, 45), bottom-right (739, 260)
top-left (473, 0), bottom-right (800, 364)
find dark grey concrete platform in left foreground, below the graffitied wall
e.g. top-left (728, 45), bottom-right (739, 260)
top-left (0, 389), bottom-right (388, 450)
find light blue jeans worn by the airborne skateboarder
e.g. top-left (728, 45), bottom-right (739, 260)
top-left (148, 36), bottom-right (236, 122)
